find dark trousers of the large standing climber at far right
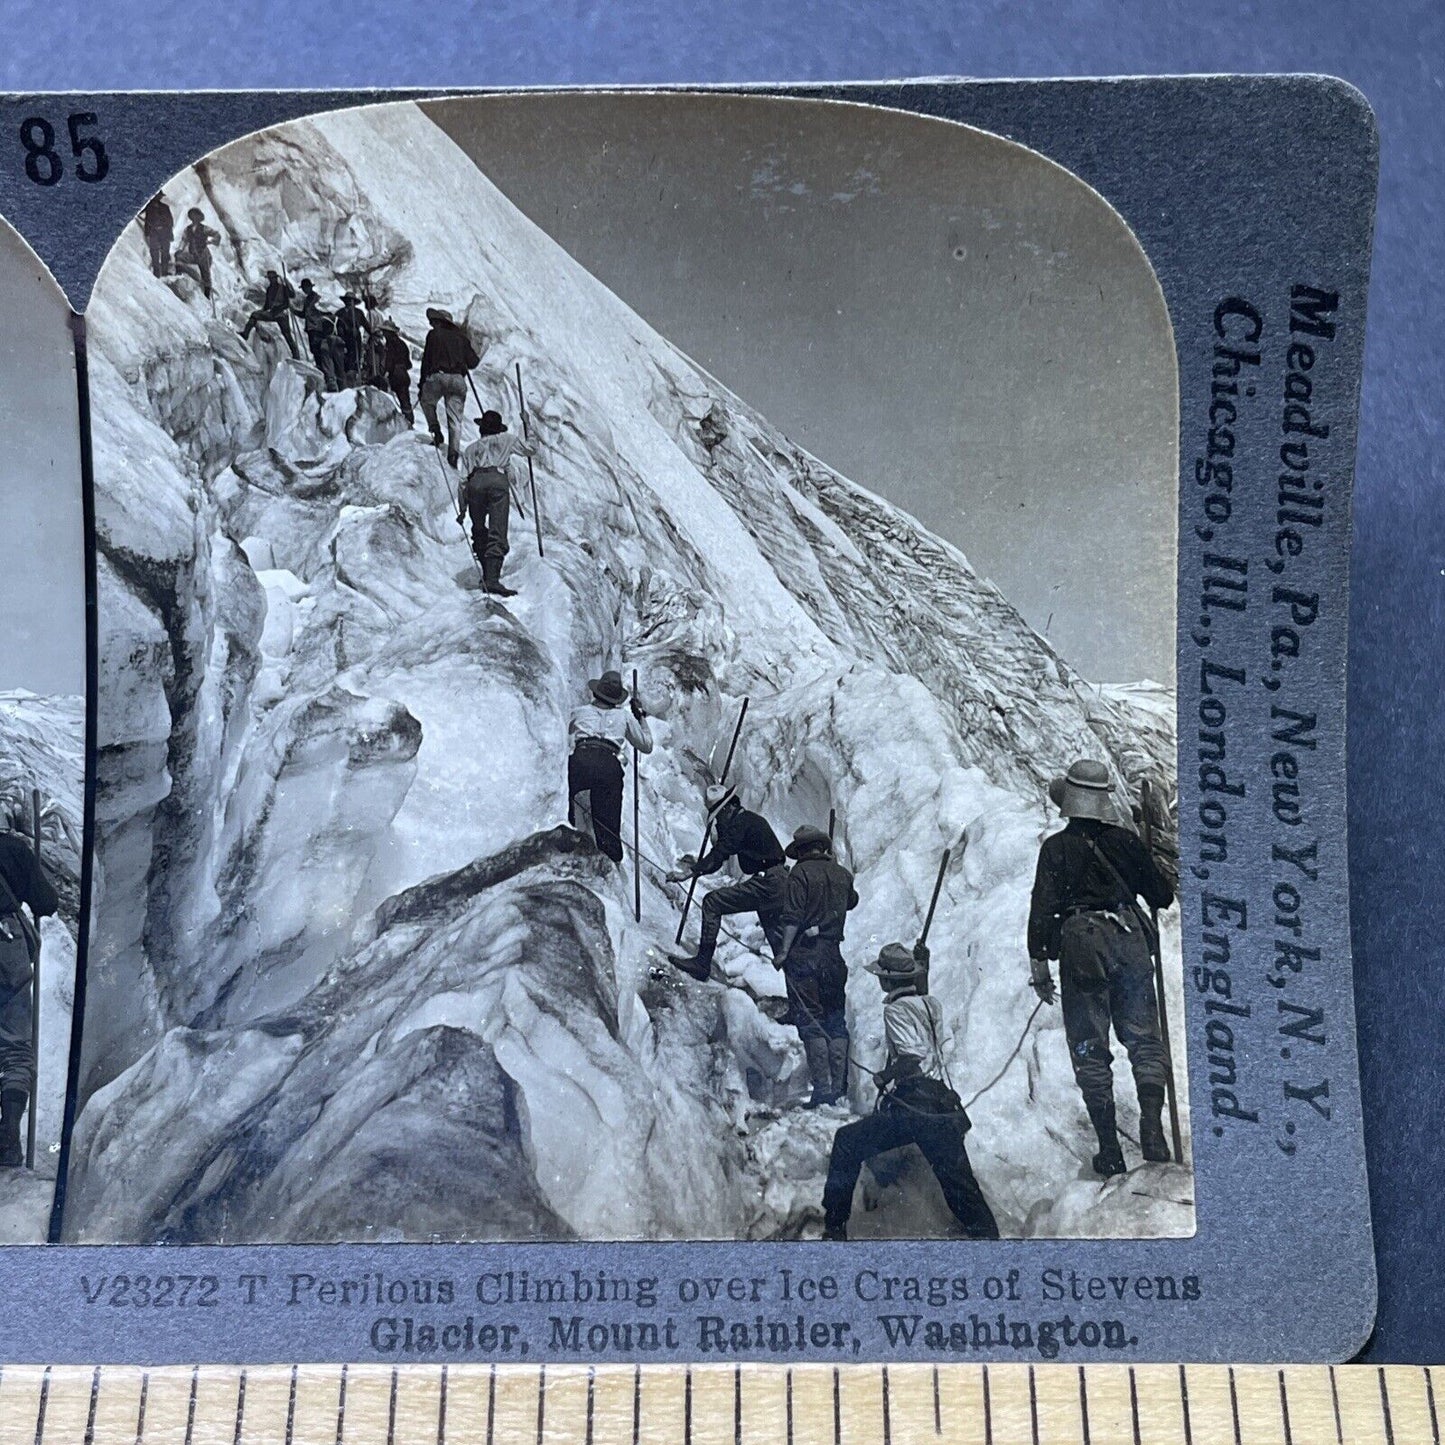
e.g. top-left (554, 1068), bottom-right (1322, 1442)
top-left (1059, 912), bottom-right (1168, 1105)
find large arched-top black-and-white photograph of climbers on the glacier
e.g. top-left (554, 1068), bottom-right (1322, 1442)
top-left (65, 94), bottom-right (1195, 1244)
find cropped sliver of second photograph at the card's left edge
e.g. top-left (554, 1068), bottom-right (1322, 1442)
top-left (0, 213), bottom-right (85, 1244)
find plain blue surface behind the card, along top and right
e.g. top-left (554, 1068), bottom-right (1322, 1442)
top-left (0, 0), bottom-right (1445, 1363)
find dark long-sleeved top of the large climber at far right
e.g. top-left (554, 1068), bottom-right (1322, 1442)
top-left (1029, 818), bottom-right (1173, 958)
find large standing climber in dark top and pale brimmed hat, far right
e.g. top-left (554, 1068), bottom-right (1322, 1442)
top-left (1029, 759), bottom-right (1173, 1178)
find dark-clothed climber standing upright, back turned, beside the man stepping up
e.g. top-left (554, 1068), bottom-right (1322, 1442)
top-left (773, 824), bottom-right (858, 1108)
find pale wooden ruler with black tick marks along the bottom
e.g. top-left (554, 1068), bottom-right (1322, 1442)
top-left (0, 1364), bottom-right (1441, 1445)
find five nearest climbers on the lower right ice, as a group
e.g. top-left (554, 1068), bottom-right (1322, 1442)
top-left (568, 687), bottom-right (1173, 1240)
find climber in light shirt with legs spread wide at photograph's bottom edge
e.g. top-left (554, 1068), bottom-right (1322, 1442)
top-left (822, 941), bottom-right (998, 1240)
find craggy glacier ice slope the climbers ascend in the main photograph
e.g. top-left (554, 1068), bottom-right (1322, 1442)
top-left (66, 105), bottom-right (1192, 1240)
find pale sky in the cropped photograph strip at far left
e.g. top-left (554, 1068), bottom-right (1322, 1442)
top-left (0, 221), bottom-right (85, 695)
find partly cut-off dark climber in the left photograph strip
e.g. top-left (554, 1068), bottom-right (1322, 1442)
top-left (0, 808), bottom-right (61, 1169)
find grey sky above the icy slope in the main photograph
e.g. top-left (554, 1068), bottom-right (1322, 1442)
top-left (425, 94), bottom-right (1178, 682)
